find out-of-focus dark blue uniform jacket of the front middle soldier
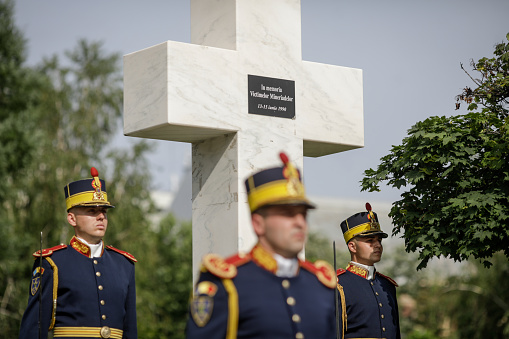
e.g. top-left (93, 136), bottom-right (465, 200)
top-left (187, 245), bottom-right (336, 339)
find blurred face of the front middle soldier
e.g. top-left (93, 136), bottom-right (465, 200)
top-left (252, 205), bottom-right (308, 258)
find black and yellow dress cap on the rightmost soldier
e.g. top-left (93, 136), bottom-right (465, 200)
top-left (341, 203), bottom-right (388, 243)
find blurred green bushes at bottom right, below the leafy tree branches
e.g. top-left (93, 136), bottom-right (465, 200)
top-left (398, 252), bottom-right (509, 339)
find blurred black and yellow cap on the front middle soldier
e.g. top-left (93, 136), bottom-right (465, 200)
top-left (245, 153), bottom-right (315, 212)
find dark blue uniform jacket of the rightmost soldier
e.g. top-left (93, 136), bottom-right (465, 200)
top-left (337, 264), bottom-right (401, 339)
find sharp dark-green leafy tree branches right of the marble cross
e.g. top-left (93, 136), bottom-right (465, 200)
top-left (362, 34), bottom-right (509, 269)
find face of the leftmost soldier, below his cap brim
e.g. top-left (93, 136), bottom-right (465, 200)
top-left (67, 206), bottom-right (108, 244)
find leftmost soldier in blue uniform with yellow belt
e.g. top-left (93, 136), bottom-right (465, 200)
top-left (19, 167), bottom-right (138, 339)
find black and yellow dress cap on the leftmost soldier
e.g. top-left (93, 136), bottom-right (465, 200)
top-left (64, 167), bottom-right (115, 210)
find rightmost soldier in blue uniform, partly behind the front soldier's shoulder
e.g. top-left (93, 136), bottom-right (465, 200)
top-left (336, 203), bottom-right (401, 339)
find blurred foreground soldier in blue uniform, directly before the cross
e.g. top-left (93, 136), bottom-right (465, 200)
top-left (186, 154), bottom-right (336, 339)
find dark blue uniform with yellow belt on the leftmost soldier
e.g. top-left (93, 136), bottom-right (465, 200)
top-left (19, 237), bottom-right (137, 339)
